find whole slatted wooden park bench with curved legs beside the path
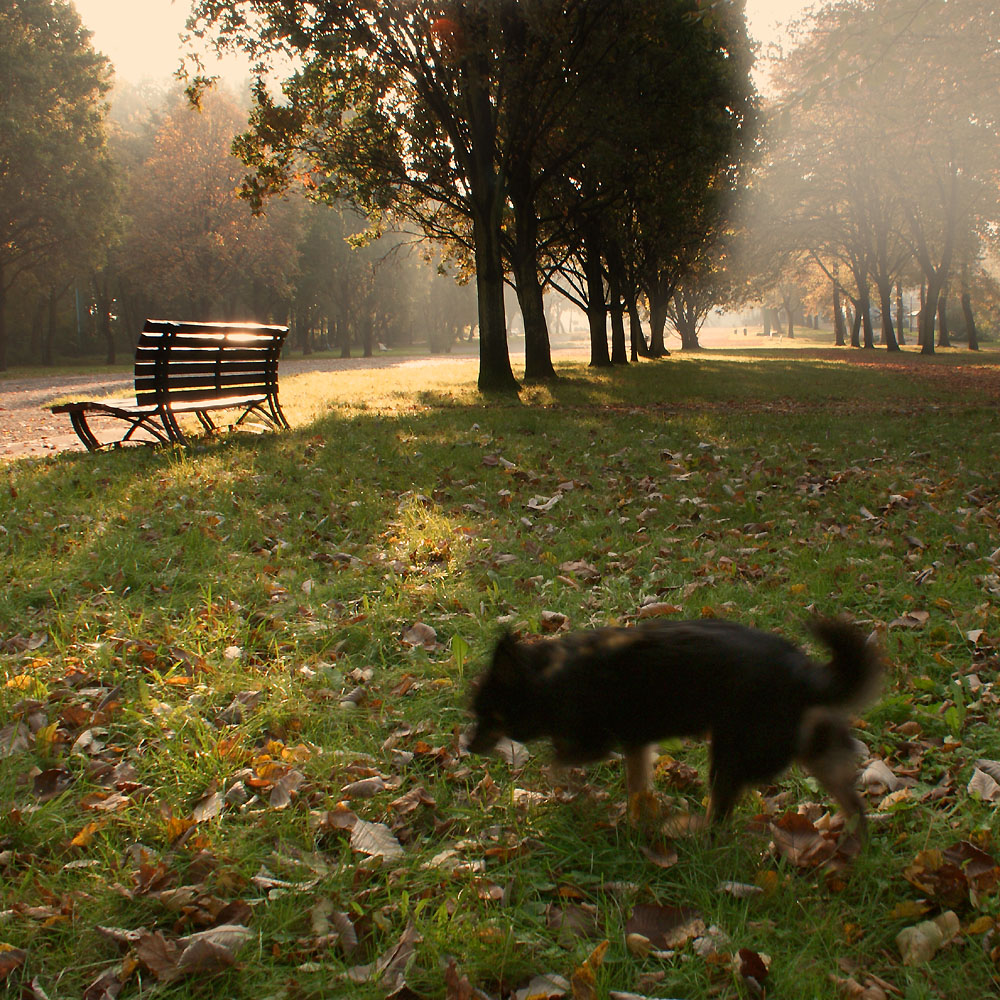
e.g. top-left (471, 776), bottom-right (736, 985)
top-left (49, 319), bottom-right (288, 451)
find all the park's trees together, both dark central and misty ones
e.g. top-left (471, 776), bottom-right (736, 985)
top-left (0, 0), bottom-right (1000, 376)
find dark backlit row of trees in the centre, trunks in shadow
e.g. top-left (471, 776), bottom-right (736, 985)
top-left (191, 0), bottom-right (757, 389)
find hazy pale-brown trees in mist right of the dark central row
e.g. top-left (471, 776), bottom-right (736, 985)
top-left (746, 0), bottom-right (1000, 353)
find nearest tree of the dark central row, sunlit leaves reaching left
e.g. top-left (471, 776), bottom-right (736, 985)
top-left (185, 0), bottom-right (517, 390)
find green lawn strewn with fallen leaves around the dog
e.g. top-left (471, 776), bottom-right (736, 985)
top-left (0, 351), bottom-right (1000, 1000)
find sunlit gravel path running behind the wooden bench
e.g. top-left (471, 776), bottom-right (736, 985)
top-left (0, 355), bottom-right (478, 460)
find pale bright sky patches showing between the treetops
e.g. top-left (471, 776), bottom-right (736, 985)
top-left (73, 0), bottom-right (812, 83)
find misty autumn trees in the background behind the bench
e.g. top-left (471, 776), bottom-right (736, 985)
top-left (0, 0), bottom-right (476, 368)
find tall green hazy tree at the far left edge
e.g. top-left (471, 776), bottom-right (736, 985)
top-left (0, 0), bottom-right (114, 370)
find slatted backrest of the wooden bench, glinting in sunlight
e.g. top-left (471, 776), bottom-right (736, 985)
top-left (135, 319), bottom-right (288, 404)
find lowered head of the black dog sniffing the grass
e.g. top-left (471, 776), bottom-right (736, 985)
top-left (465, 635), bottom-right (534, 753)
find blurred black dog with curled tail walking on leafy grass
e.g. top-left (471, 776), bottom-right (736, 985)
top-left (468, 619), bottom-right (881, 832)
